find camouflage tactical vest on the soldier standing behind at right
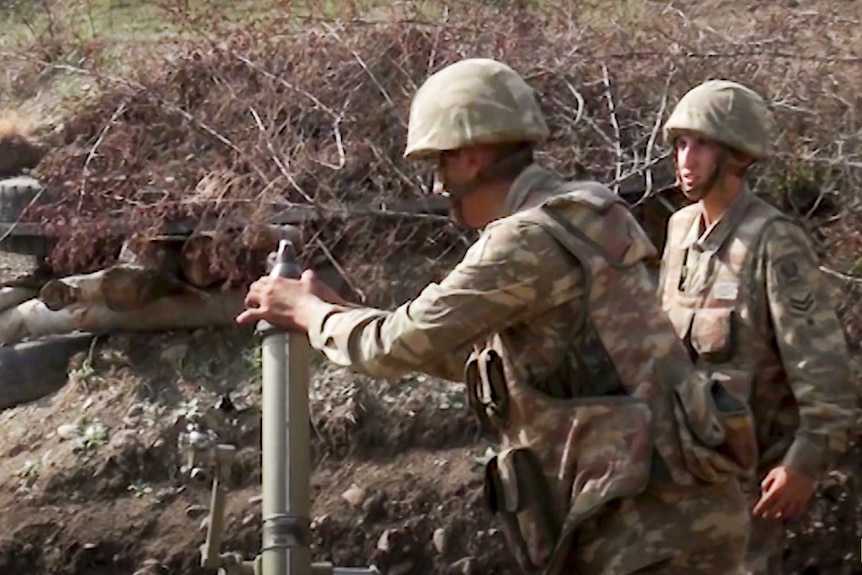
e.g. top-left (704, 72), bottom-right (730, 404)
top-left (661, 196), bottom-right (799, 468)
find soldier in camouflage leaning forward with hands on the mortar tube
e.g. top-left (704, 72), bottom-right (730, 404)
top-left (237, 59), bottom-right (754, 575)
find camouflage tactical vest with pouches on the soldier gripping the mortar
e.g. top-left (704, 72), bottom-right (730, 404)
top-left (465, 183), bottom-right (754, 574)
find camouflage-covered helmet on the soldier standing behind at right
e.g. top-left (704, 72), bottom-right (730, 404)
top-left (664, 80), bottom-right (773, 159)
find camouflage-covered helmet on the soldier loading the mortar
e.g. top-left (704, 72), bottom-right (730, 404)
top-left (404, 58), bottom-right (549, 159)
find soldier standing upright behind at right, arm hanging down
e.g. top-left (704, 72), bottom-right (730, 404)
top-left (660, 80), bottom-right (856, 573)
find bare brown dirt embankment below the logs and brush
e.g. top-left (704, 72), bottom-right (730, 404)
top-left (0, 331), bottom-right (862, 575)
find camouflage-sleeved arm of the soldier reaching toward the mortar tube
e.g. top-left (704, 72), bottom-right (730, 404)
top-left (309, 222), bottom-right (584, 381)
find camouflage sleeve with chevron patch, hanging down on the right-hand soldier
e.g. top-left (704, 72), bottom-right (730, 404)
top-left (764, 221), bottom-right (856, 479)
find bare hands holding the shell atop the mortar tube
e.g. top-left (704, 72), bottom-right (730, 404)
top-left (236, 270), bottom-right (324, 331)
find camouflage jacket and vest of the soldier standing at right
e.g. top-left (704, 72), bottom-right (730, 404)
top-left (660, 189), bottom-right (856, 478)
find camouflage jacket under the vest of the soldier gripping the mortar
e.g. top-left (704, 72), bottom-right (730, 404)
top-left (309, 162), bottom-right (586, 385)
